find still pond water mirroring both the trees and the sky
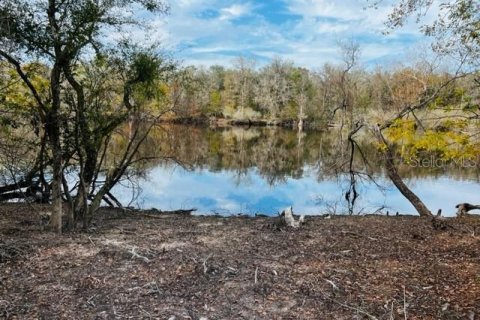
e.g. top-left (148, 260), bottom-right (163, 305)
top-left (114, 126), bottom-right (480, 216)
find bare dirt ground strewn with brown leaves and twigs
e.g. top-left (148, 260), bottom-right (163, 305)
top-left (0, 204), bottom-right (480, 320)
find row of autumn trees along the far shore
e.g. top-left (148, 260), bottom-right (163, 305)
top-left (166, 52), bottom-right (477, 129)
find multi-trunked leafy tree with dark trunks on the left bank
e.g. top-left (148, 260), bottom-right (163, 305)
top-left (0, 0), bottom-right (168, 232)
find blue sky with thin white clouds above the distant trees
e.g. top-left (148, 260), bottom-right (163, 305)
top-left (143, 0), bottom-right (438, 68)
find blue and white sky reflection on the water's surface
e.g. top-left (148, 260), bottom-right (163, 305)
top-left (110, 167), bottom-right (480, 216)
